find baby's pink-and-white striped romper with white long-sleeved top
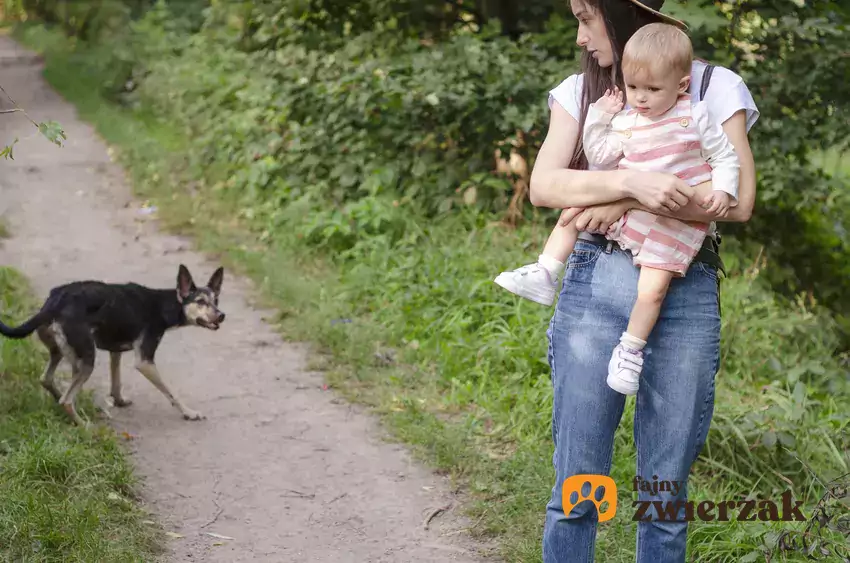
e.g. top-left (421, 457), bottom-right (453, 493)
top-left (583, 95), bottom-right (739, 277)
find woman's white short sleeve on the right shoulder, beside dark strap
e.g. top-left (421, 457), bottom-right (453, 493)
top-left (690, 61), bottom-right (759, 130)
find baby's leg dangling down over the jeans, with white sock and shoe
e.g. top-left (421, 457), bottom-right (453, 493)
top-left (608, 266), bottom-right (675, 395)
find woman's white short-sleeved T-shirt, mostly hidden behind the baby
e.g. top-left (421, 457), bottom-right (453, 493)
top-left (549, 61), bottom-right (759, 172)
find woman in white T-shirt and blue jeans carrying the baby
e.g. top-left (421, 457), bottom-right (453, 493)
top-left (530, 0), bottom-right (758, 563)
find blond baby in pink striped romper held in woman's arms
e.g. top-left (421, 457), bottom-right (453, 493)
top-left (495, 24), bottom-right (739, 395)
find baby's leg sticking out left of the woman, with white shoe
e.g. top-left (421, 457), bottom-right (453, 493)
top-left (494, 209), bottom-right (578, 305)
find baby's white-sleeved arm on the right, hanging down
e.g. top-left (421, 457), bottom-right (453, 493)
top-left (693, 102), bottom-right (741, 207)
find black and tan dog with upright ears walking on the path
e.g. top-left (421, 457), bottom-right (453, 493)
top-left (0, 264), bottom-right (224, 426)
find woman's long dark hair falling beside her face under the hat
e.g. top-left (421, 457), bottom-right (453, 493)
top-left (570, 0), bottom-right (662, 170)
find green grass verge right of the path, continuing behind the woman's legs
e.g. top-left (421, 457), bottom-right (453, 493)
top-left (11, 22), bottom-right (850, 563)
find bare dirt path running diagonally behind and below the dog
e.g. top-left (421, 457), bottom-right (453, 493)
top-left (0, 36), bottom-right (496, 563)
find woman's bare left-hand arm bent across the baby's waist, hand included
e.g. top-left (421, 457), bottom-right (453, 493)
top-left (529, 101), bottom-right (694, 213)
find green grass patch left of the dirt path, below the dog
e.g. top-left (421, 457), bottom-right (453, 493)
top-left (0, 267), bottom-right (161, 563)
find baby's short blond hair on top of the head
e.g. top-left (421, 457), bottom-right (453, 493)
top-left (622, 23), bottom-right (694, 80)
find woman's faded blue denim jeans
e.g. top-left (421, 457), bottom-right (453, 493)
top-left (543, 239), bottom-right (720, 563)
